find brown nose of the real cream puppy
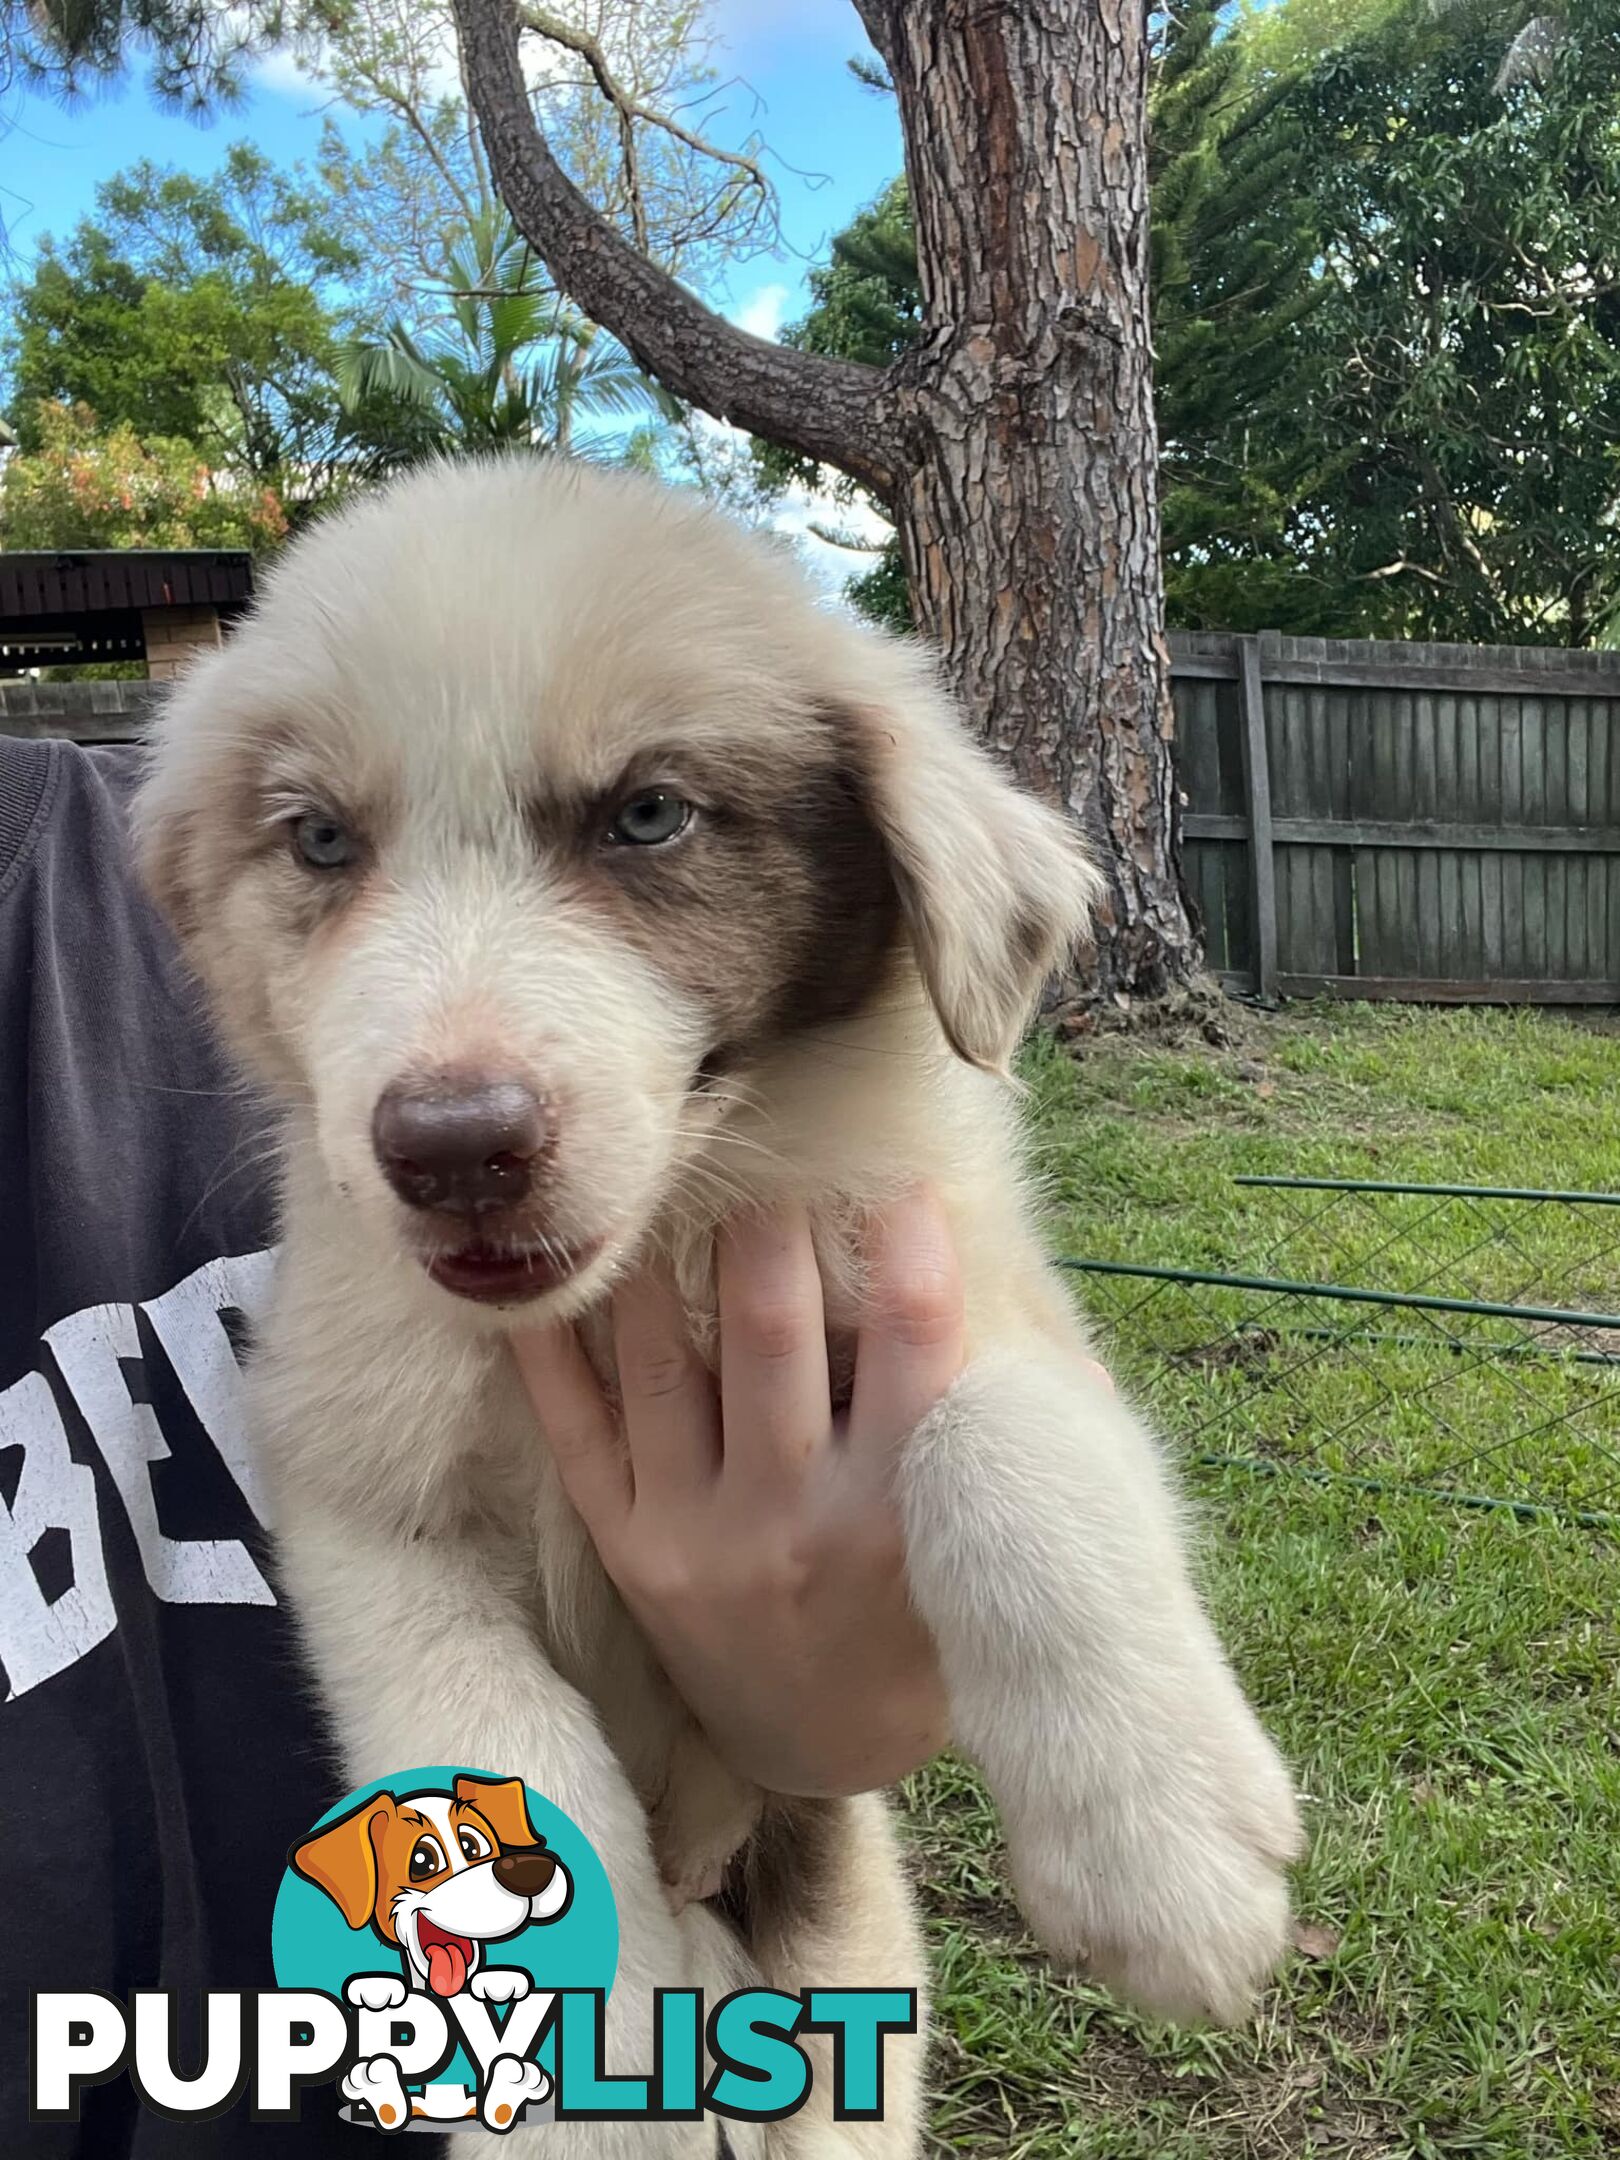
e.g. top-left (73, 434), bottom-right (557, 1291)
top-left (372, 1078), bottom-right (557, 1216)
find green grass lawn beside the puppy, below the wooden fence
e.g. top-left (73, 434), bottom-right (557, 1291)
top-left (909, 1007), bottom-right (1620, 2160)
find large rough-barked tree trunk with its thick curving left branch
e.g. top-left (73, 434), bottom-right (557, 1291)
top-left (454, 0), bottom-right (1199, 1011)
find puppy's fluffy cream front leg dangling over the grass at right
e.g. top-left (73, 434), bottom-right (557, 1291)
top-left (901, 1350), bottom-right (1300, 2020)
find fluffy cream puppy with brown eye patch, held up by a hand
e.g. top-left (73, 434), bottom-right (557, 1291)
top-left (138, 447), bottom-right (1298, 2156)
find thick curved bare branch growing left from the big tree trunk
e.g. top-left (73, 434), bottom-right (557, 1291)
top-left (454, 0), bottom-right (899, 497)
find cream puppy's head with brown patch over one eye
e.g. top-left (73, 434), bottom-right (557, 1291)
top-left (140, 464), bottom-right (1084, 1311)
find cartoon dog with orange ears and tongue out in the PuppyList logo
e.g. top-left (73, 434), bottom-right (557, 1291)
top-left (289, 1776), bottom-right (575, 2130)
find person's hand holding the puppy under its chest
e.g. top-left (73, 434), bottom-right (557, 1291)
top-left (512, 1192), bottom-right (963, 1795)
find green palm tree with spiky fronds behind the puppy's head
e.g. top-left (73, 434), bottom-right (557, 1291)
top-left (337, 210), bottom-right (680, 464)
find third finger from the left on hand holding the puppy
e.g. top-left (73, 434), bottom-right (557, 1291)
top-left (717, 1207), bottom-right (832, 1482)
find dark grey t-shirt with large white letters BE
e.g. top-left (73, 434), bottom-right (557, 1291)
top-left (0, 737), bottom-right (406, 2160)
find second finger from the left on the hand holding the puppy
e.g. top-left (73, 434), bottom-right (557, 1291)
top-left (613, 1266), bottom-right (719, 1501)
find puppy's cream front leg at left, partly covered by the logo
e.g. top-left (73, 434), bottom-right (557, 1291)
top-left (279, 1508), bottom-right (713, 2160)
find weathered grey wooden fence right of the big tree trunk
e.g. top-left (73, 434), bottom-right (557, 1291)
top-left (1171, 633), bottom-right (1620, 1004)
